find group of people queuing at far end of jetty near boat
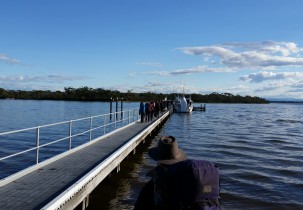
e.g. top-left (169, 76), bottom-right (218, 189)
top-left (139, 101), bottom-right (167, 123)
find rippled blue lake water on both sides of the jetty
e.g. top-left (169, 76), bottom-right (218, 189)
top-left (0, 100), bottom-right (303, 209)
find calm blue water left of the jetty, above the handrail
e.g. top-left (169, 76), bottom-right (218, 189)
top-left (0, 100), bottom-right (139, 132)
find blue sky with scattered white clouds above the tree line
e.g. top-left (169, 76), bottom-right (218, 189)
top-left (0, 0), bottom-right (303, 100)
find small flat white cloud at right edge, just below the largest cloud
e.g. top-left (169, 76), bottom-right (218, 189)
top-left (240, 71), bottom-right (303, 83)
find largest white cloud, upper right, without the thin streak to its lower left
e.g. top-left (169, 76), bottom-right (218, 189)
top-left (179, 41), bottom-right (303, 70)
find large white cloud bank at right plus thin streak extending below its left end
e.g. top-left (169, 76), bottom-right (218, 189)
top-left (146, 41), bottom-right (303, 76)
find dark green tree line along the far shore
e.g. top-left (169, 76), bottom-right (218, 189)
top-left (0, 86), bottom-right (268, 103)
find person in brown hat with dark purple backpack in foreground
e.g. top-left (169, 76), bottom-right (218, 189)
top-left (134, 136), bottom-right (221, 210)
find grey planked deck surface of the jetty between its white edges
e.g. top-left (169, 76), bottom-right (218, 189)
top-left (0, 115), bottom-right (164, 210)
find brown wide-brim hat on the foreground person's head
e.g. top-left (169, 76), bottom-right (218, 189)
top-left (148, 136), bottom-right (186, 164)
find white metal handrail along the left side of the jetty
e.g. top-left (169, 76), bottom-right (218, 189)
top-left (0, 109), bottom-right (139, 175)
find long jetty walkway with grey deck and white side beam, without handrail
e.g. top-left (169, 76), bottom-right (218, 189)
top-left (0, 109), bottom-right (170, 210)
